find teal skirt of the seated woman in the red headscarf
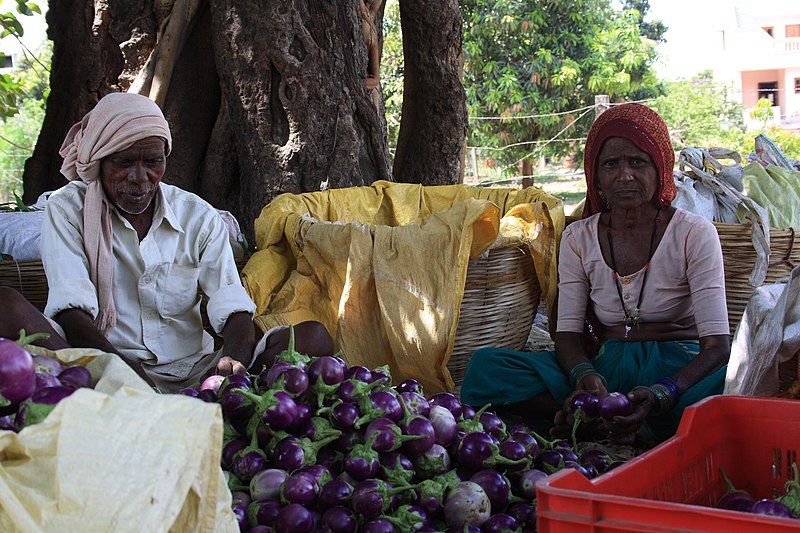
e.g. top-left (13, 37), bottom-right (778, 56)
top-left (461, 339), bottom-right (726, 440)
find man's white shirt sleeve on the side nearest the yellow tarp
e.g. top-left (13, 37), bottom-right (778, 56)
top-left (199, 213), bottom-right (256, 334)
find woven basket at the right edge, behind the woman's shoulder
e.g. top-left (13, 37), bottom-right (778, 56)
top-left (714, 222), bottom-right (800, 335)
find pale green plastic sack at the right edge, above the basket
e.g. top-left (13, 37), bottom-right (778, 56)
top-left (742, 163), bottom-right (800, 228)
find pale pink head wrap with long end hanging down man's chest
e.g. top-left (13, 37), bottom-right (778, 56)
top-left (58, 93), bottom-right (172, 333)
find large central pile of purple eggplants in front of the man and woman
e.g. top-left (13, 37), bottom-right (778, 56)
top-left (188, 334), bottom-right (616, 533)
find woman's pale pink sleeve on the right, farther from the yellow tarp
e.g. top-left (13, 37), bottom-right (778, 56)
top-left (686, 220), bottom-right (730, 337)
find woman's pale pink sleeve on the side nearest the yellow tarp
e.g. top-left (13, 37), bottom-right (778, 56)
top-left (556, 227), bottom-right (589, 333)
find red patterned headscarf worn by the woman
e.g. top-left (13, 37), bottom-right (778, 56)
top-left (583, 104), bottom-right (676, 218)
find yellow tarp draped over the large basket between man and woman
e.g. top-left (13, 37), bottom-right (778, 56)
top-left (243, 181), bottom-right (564, 393)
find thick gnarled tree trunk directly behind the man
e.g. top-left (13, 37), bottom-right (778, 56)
top-left (24, 0), bottom-right (390, 240)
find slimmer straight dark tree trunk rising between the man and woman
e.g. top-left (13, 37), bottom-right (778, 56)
top-left (393, 0), bottom-right (467, 185)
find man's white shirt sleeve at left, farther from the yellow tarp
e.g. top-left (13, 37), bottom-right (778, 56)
top-left (42, 200), bottom-right (98, 319)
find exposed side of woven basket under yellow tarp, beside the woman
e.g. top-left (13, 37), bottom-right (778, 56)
top-left (447, 247), bottom-right (541, 387)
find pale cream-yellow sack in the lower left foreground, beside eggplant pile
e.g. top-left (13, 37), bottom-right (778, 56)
top-left (0, 346), bottom-right (238, 533)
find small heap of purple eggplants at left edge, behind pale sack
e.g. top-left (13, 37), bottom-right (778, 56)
top-left (0, 330), bottom-right (92, 431)
